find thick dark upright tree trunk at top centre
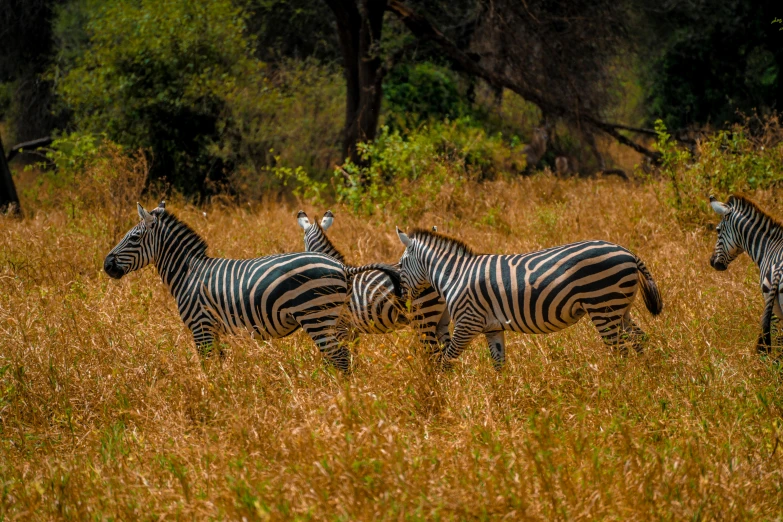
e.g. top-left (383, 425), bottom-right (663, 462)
top-left (326, 0), bottom-right (387, 163)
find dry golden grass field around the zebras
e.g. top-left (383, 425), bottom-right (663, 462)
top-left (0, 176), bottom-right (783, 520)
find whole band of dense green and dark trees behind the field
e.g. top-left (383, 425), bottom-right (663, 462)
top-left (0, 0), bottom-right (783, 199)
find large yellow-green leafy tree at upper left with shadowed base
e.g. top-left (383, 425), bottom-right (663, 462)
top-left (50, 0), bottom-right (262, 193)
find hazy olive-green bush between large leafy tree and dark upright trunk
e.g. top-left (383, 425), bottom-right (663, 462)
top-left (219, 60), bottom-right (345, 199)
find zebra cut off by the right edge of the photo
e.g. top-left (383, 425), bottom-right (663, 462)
top-left (710, 194), bottom-right (783, 353)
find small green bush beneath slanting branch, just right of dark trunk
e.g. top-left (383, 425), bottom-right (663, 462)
top-left (383, 62), bottom-right (470, 129)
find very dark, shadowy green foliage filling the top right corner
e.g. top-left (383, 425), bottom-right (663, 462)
top-left (641, 0), bottom-right (783, 128)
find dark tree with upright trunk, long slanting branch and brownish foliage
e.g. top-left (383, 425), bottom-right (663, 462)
top-left (326, 0), bottom-right (657, 166)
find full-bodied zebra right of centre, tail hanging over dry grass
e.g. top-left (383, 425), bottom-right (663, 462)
top-left (397, 229), bottom-right (663, 369)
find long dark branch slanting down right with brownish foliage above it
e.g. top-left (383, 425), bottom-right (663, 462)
top-left (388, 0), bottom-right (659, 161)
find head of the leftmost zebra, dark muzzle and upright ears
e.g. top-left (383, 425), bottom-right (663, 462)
top-left (103, 201), bottom-right (166, 279)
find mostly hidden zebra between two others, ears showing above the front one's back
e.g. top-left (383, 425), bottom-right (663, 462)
top-left (296, 210), bottom-right (449, 352)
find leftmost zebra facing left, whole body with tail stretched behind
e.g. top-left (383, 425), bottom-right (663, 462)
top-left (103, 201), bottom-right (400, 372)
